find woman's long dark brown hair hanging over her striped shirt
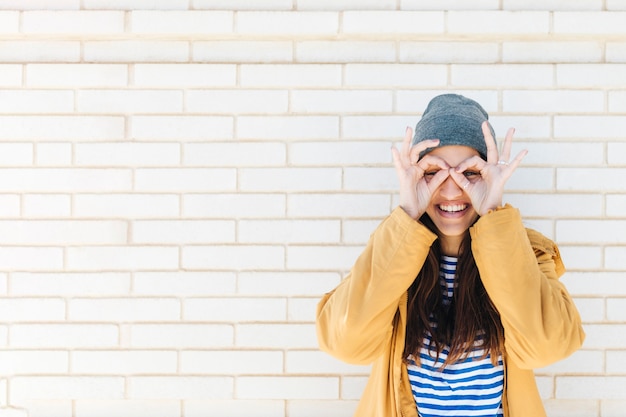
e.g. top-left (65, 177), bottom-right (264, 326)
top-left (404, 214), bottom-right (504, 368)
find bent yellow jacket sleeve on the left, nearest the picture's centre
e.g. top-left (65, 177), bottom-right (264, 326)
top-left (316, 207), bottom-right (436, 364)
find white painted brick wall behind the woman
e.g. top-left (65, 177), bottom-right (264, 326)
top-left (0, 0), bottom-right (626, 417)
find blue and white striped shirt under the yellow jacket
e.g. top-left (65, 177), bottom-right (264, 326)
top-left (407, 256), bottom-right (504, 417)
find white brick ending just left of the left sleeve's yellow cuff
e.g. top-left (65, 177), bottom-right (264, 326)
top-left (287, 193), bottom-right (390, 218)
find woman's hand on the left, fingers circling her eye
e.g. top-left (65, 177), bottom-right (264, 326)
top-left (391, 127), bottom-right (450, 220)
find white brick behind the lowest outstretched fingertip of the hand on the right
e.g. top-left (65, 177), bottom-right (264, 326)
top-left (510, 141), bottom-right (604, 167)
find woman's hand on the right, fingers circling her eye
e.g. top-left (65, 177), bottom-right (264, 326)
top-left (450, 122), bottom-right (528, 216)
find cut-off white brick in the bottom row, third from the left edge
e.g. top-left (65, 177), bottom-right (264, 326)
top-left (183, 398), bottom-right (282, 417)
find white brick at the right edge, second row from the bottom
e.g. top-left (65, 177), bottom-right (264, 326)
top-left (556, 376), bottom-right (626, 400)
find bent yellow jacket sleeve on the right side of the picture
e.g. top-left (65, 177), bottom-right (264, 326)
top-left (470, 205), bottom-right (585, 369)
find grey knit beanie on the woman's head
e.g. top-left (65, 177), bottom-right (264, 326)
top-left (412, 94), bottom-right (496, 160)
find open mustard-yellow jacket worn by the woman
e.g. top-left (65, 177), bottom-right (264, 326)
top-left (317, 205), bottom-right (585, 417)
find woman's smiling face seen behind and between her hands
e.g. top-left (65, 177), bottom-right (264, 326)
top-left (425, 145), bottom-right (480, 247)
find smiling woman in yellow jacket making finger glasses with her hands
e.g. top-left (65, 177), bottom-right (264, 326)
top-left (317, 94), bottom-right (584, 417)
